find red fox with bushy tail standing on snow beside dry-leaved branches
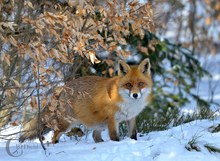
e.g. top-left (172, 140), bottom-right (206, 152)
top-left (19, 59), bottom-right (152, 144)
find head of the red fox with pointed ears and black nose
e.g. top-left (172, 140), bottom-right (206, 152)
top-left (119, 59), bottom-right (152, 99)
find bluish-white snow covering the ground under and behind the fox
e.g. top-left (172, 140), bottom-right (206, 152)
top-left (0, 56), bottom-right (220, 161)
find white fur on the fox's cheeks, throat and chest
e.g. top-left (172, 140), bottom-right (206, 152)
top-left (115, 89), bottom-right (150, 122)
